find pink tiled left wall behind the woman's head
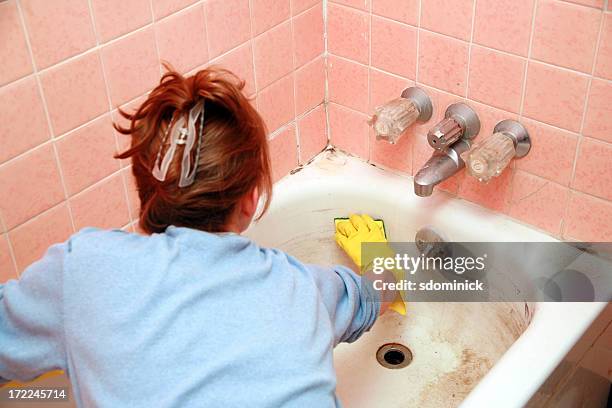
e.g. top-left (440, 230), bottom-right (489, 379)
top-left (0, 0), bottom-right (327, 282)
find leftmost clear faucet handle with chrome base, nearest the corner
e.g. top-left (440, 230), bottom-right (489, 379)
top-left (368, 87), bottom-right (433, 144)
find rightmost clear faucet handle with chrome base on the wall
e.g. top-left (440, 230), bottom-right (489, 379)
top-left (466, 120), bottom-right (531, 182)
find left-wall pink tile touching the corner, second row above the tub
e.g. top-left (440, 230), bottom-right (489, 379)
top-left (295, 57), bottom-right (325, 115)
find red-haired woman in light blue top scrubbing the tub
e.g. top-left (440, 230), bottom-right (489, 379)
top-left (0, 69), bottom-right (400, 407)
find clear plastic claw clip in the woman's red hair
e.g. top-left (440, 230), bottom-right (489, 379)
top-left (151, 101), bottom-right (204, 187)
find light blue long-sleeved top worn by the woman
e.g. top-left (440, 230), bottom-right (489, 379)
top-left (0, 227), bottom-right (379, 408)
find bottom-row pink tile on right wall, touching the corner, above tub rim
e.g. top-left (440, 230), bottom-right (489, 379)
top-left (328, 103), bottom-right (369, 159)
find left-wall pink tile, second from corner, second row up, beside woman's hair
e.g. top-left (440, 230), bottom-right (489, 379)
top-left (257, 75), bottom-right (295, 133)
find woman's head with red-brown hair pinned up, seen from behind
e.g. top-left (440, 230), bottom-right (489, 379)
top-left (115, 68), bottom-right (272, 233)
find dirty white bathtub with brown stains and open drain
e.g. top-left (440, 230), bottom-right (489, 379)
top-left (247, 149), bottom-right (609, 408)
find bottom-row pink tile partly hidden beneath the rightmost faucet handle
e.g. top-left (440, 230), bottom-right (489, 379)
top-left (459, 166), bottom-right (513, 213)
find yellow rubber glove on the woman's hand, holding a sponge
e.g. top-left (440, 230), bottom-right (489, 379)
top-left (335, 214), bottom-right (406, 315)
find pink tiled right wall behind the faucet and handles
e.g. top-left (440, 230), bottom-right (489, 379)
top-left (327, 0), bottom-right (612, 241)
